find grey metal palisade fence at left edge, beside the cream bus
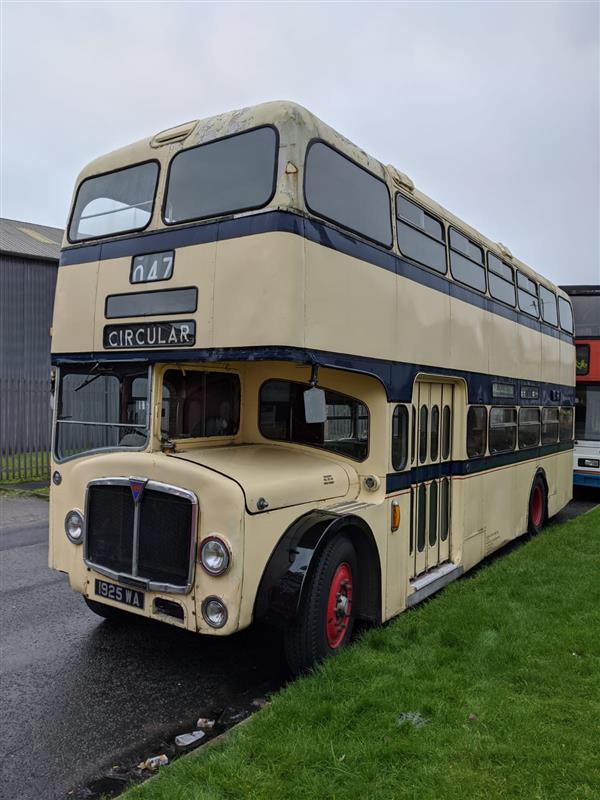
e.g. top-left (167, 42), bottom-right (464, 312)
top-left (0, 377), bottom-right (52, 482)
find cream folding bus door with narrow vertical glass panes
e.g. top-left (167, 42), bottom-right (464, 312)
top-left (411, 381), bottom-right (454, 577)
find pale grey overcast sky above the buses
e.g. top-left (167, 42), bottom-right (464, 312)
top-left (1, 0), bottom-right (600, 283)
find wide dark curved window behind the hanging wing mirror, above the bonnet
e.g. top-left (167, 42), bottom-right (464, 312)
top-left (259, 380), bottom-right (369, 461)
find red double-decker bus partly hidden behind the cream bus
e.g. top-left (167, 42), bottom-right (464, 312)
top-left (562, 286), bottom-right (600, 490)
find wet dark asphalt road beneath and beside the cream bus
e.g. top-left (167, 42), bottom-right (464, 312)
top-left (0, 488), bottom-right (595, 800)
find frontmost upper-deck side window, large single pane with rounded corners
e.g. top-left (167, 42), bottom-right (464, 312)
top-left (304, 141), bottom-right (392, 247)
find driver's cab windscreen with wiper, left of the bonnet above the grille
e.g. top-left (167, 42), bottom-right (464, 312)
top-left (55, 364), bottom-right (149, 460)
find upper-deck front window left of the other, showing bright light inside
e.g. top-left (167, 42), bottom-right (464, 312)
top-left (69, 161), bottom-right (158, 242)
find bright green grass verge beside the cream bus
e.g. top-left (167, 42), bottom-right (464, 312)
top-left (125, 510), bottom-right (600, 800)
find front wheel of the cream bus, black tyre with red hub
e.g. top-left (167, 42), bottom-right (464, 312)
top-left (284, 535), bottom-right (358, 675)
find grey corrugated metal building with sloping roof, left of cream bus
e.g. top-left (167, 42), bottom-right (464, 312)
top-left (0, 219), bottom-right (63, 480)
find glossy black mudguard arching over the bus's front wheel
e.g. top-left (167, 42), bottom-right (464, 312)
top-left (254, 510), bottom-right (381, 628)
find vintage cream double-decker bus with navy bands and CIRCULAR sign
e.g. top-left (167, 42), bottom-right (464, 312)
top-left (49, 102), bottom-right (575, 672)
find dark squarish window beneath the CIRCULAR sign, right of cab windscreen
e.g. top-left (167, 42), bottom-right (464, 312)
top-left (161, 369), bottom-right (240, 439)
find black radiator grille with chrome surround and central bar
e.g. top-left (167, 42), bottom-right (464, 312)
top-left (85, 478), bottom-right (197, 592)
